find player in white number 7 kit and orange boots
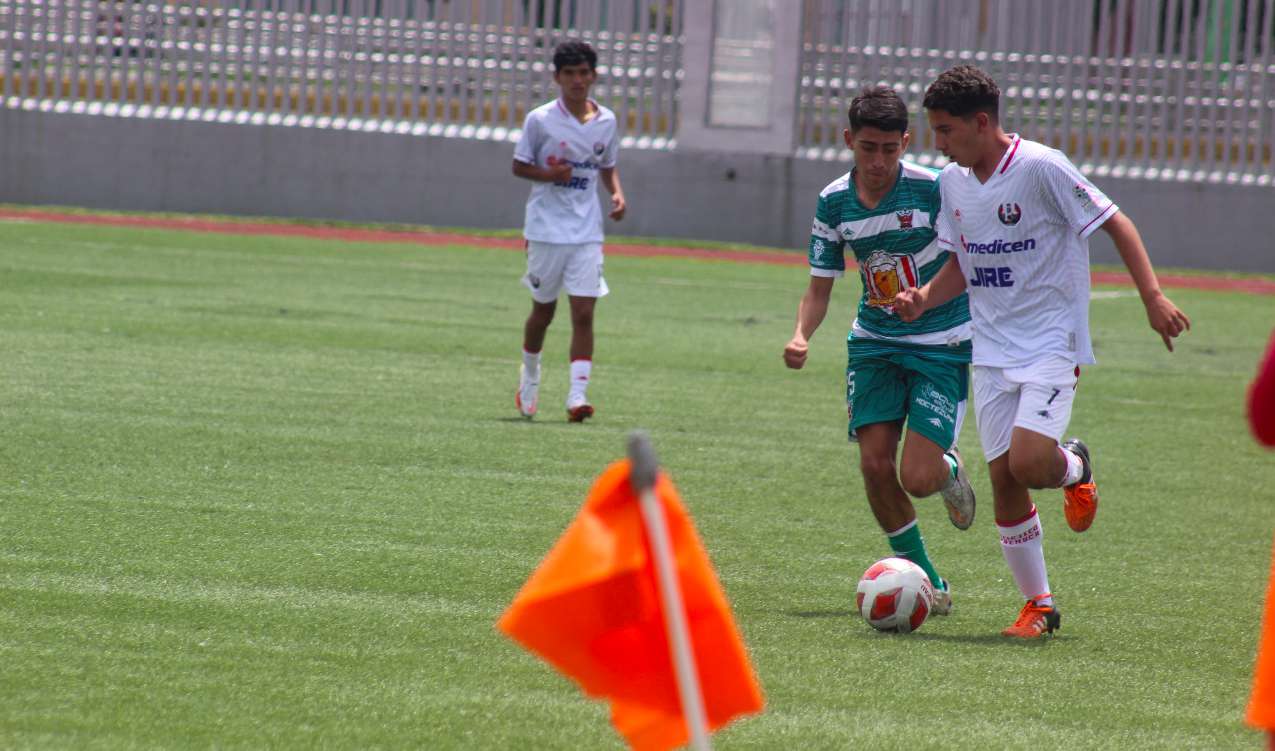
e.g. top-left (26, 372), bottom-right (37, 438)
top-left (895, 65), bottom-right (1191, 638)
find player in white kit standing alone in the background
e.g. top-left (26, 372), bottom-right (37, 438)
top-left (514, 41), bottom-right (626, 422)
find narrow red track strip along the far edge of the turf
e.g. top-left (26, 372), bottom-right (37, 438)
top-left (0, 209), bottom-right (1275, 295)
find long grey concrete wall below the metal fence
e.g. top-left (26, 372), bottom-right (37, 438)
top-left (0, 108), bottom-right (1275, 273)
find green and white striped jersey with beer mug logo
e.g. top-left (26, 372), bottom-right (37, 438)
top-left (810, 161), bottom-right (972, 362)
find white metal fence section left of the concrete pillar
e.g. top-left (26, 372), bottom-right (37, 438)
top-left (0, 0), bottom-right (682, 145)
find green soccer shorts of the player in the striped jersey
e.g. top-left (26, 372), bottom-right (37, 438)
top-left (845, 344), bottom-right (969, 450)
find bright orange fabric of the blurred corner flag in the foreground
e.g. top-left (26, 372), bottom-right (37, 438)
top-left (497, 460), bottom-right (762, 751)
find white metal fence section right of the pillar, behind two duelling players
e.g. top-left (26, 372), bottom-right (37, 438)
top-left (799, 0), bottom-right (1275, 185)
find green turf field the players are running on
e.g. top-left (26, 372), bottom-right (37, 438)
top-left (0, 215), bottom-right (1275, 750)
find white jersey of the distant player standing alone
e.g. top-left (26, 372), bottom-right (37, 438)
top-left (514, 99), bottom-right (620, 245)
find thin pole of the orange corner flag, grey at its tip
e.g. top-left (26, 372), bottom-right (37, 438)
top-left (629, 431), bottom-right (711, 751)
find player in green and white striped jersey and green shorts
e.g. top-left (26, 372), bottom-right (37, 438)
top-left (784, 87), bottom-right (974, 615)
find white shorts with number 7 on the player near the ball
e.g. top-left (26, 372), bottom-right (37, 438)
top-left (974, 357), bottom-right (1080, 462)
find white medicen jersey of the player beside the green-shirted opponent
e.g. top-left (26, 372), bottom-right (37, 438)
top-left (938, 134), bottom-right (1119, 367)
